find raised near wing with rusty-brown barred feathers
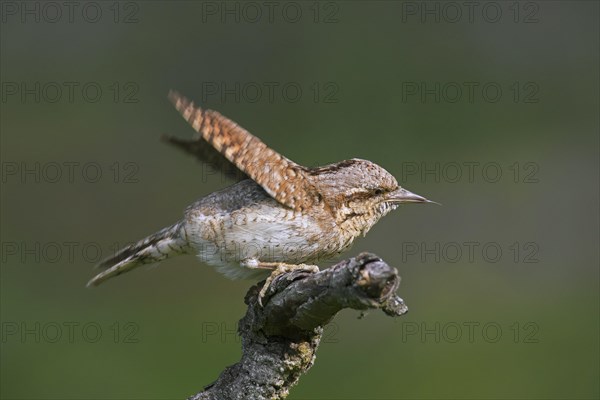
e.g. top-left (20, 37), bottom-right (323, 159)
top-left (169, 91), bottom-right (319, 210)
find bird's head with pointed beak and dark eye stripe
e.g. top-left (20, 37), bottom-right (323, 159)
top-left (310, 158), bottom-right (432, 235)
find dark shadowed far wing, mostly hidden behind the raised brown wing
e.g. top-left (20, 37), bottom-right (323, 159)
top-left (161, 135), bottom-right (249, 182)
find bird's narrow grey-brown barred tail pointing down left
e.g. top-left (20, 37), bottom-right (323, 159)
top-left (87, 222), bottom-right (188, 287)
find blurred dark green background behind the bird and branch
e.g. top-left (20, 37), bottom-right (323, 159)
top-left (0, 1), bottom-right (600, 399)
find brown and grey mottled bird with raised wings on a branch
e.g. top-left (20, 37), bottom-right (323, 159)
top-left (87, 91), bottom-right (435, 293)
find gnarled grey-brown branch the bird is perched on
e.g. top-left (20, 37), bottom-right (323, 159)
top-left (189, 253), bottom-right (408, 400)
